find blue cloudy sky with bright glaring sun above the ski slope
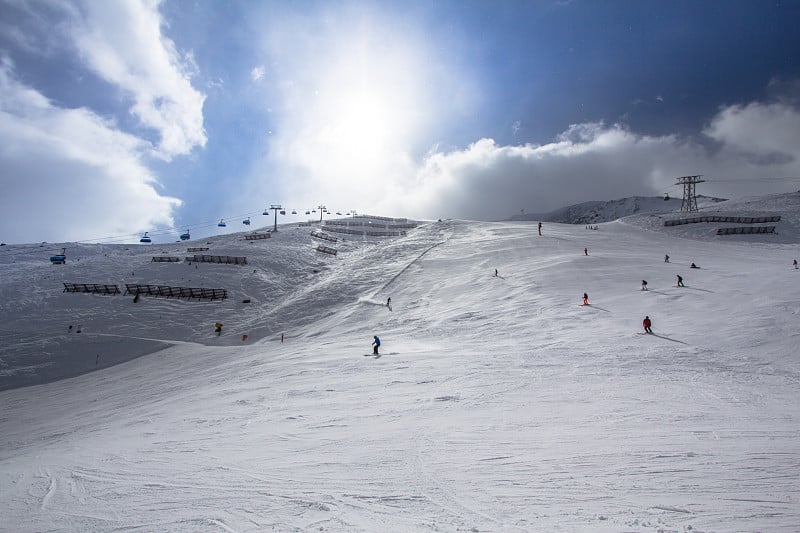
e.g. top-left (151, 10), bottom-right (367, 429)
top-left (0, 0), bottom-right (800, 243)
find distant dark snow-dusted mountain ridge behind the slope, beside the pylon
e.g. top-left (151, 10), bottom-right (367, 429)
top-left (510, 196), bottom-right (725, 224)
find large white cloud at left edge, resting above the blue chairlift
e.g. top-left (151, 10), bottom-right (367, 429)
top-left (0, 60), bottom-right (180, 242)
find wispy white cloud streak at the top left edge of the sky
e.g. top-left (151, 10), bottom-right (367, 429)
top-left (73, 0), bottom-right (206, 160)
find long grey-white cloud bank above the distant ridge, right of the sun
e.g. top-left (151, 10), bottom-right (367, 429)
top-left (382, 103), bottom-right (800, 220)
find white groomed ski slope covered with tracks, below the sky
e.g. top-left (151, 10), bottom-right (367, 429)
top-left (0, 195), bottom-right (800, 532)
